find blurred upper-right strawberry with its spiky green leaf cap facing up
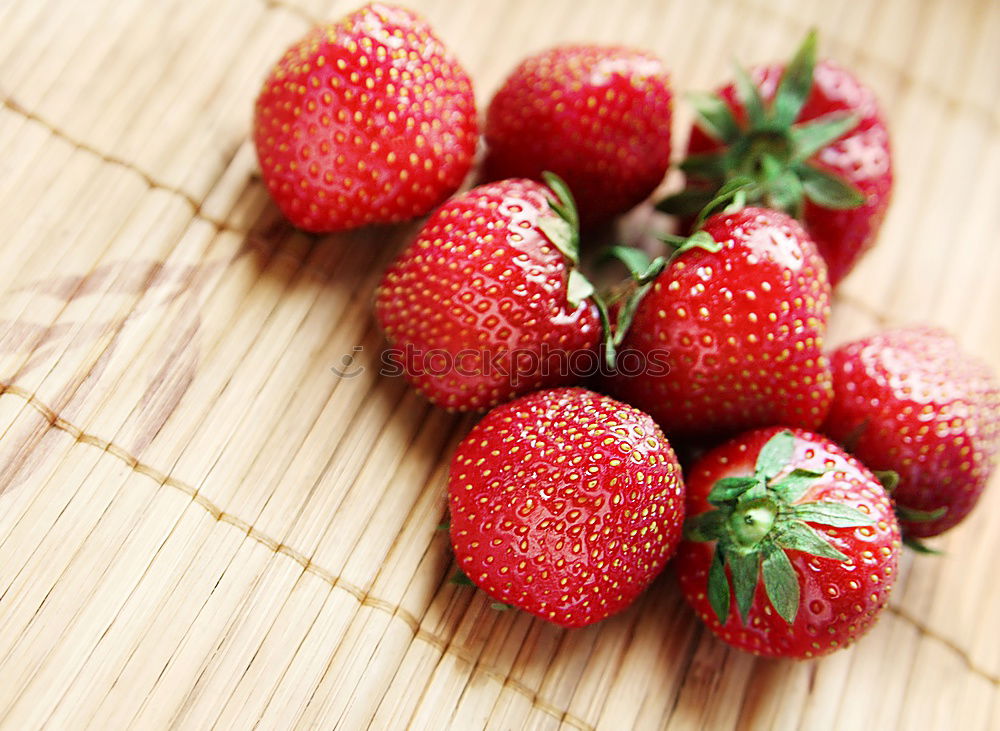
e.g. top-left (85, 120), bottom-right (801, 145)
top-left (663, 33), bottom-right (892, 285)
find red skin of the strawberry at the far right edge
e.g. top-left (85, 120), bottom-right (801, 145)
top-left (823, 327), bottom-right (1000, 537)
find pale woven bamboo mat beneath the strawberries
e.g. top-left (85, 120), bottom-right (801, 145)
top-left (0, 0), bottom-right (1000, 729)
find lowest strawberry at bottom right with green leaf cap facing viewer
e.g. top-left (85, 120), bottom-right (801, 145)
top-left (677, 427), bottom-right (901, 658)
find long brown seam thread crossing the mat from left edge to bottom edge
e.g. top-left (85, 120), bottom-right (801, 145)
top-left (0, 383), bottom-right (594, 731)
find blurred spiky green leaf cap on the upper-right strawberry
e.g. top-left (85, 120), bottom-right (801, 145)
top-left (657, 31), bottom-right (865, 222)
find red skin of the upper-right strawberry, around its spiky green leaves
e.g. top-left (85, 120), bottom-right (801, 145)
top-left (688, 61), bottom-right (892, 285)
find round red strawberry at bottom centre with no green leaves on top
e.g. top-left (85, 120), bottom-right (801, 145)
top-left (448, 388), bottom-right (684, 627)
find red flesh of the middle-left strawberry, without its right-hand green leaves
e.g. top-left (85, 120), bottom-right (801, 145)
top-left (375, 180), bottom-right (601, 411)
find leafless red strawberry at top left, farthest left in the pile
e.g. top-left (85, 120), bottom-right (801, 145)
top-left (253, 4), bottom-right (477, 232)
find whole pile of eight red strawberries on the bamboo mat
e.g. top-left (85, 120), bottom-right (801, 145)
top-left (254, 4), bottom-right (1000, 657)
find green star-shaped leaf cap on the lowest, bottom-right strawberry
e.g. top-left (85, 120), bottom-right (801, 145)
top-left (684, 431), bottom-right (874, 624)
